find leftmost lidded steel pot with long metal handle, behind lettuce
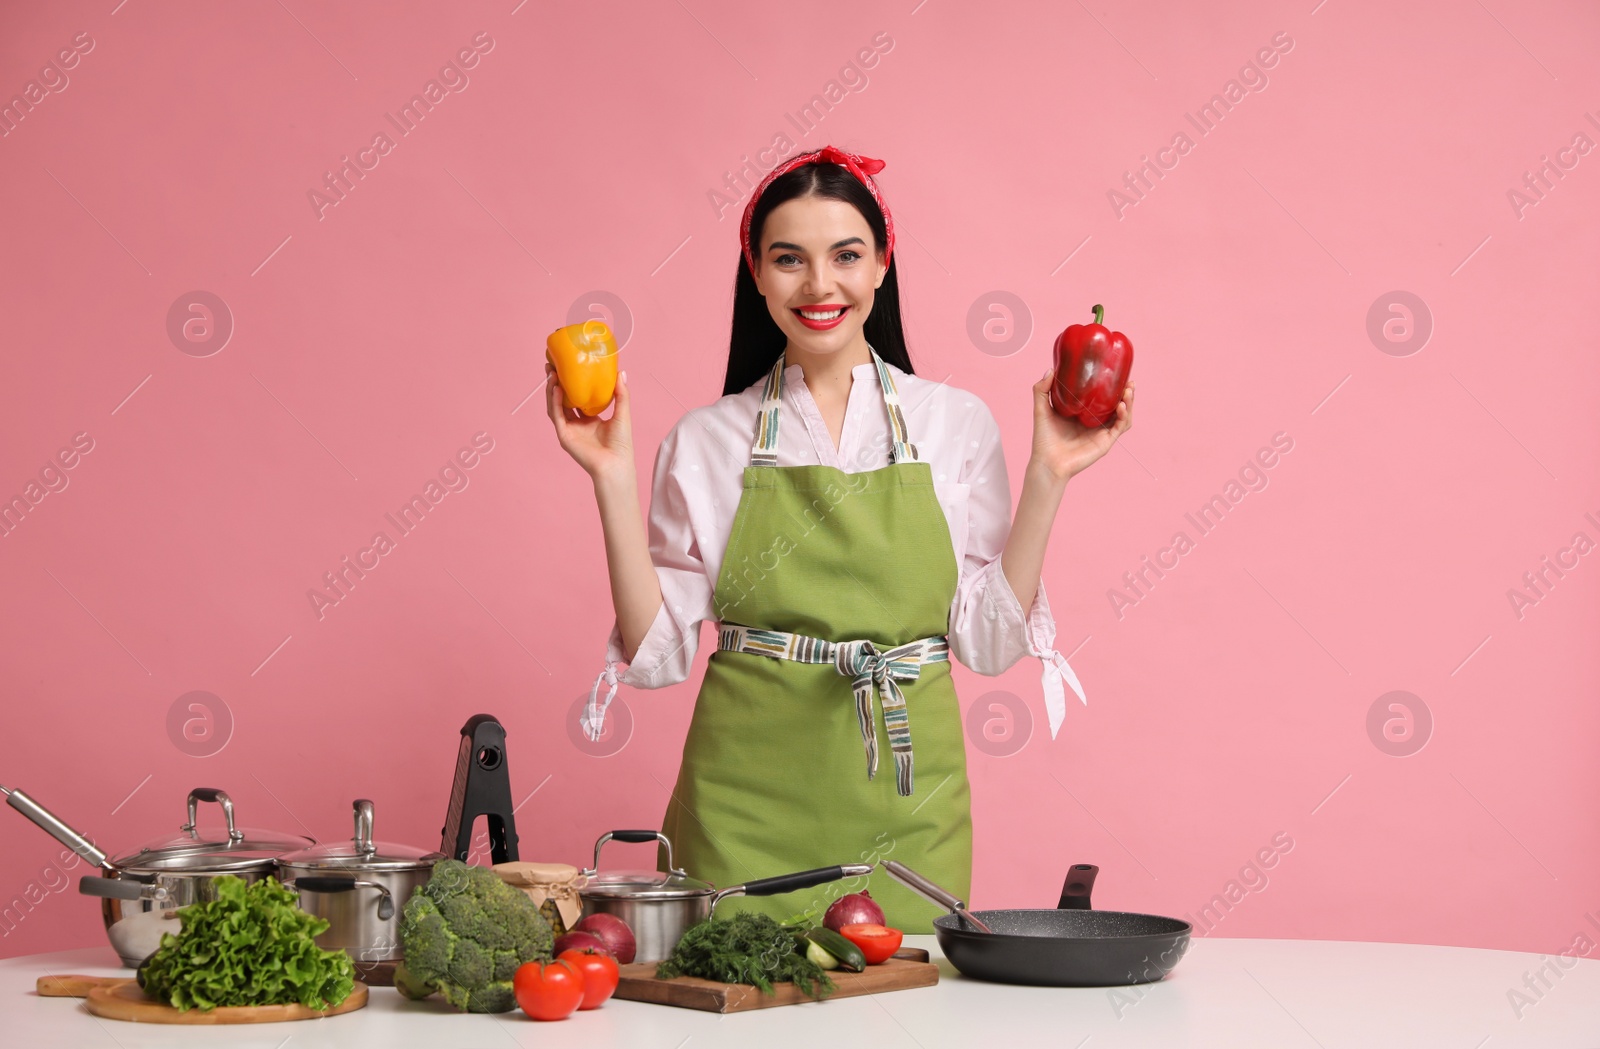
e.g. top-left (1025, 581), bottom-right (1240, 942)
top-left (0, 787), bottom-right (314, 969)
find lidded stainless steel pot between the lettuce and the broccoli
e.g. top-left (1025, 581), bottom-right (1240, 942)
top-left (278, 798), bottom-right (445, 967)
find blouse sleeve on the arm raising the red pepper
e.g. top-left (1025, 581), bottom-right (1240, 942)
top-left (949, 401), bottom-right (1088, 739)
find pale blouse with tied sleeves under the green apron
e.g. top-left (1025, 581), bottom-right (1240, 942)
top-left (586, 361), bottom-right (1088, 739)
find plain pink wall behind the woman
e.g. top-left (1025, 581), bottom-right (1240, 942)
top-left (0, 0), bottom-right (1600, 955)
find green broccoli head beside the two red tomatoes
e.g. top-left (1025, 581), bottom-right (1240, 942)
top-left (395, 860), bottom-right (554, 1012)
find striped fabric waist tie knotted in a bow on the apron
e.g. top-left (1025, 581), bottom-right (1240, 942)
top-left (717, 624), bottom-right (950, 796)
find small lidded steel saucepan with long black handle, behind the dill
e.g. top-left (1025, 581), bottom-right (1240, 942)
top-left (578, 830), bottom-right (872, 963)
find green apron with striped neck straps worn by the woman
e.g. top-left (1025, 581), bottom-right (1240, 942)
top-left (658, 352), bottom-right (973, 934)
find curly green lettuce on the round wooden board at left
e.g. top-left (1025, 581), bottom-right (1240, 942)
top-left (139, 875), bottom-right (355, 1011)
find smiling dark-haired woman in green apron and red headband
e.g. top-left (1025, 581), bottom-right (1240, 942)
top-left (547, 146), bottom-right (1133, 932)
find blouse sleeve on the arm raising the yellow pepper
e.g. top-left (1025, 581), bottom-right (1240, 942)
top-left (584, 422), bottom-right (712, 739)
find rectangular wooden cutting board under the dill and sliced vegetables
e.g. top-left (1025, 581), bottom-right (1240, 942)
top-left (613, 947), bottom-right (939, 1012)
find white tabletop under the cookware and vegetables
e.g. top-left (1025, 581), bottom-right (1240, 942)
top-left (0, 935), bottom-right (1600, 1049)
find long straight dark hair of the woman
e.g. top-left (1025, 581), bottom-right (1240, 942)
top-left (722, 163), bottom-right (912, 395)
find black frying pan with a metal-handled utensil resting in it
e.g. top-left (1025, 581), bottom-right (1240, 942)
top-left (883, 860), bottom-right (1194, 987)
